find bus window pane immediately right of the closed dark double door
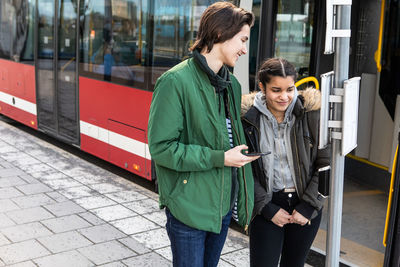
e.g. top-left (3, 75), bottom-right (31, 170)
top-left (80, 0), bottom-right (146, 89)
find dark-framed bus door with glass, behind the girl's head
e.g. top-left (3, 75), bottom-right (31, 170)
top-left (249, 0), bottom-right (333, 90)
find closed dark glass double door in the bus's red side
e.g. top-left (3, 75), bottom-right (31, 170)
top-left (36, 0), bottom-right (79, 144)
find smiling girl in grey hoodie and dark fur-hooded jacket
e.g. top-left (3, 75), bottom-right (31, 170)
top-left (243, 58), bottom-right (329, 267)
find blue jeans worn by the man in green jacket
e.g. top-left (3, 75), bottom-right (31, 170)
top-left (165, 209), bottom-right (232, 267)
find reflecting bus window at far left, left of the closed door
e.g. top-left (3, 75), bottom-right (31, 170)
top-left (0, 0), bottom-right (35, 64)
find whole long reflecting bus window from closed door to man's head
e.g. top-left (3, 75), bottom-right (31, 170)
top-left (80, 0), bottom-right (237, 90)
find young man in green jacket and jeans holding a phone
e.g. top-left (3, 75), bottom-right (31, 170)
top-left (148, 2), bottom-right (258, 267)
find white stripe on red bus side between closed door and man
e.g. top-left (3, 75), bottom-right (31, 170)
top-left (80, 121), bottom-right (151, 160)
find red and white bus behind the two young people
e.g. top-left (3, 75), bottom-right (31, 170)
top-left (0, 0), bottom-right (400, 191)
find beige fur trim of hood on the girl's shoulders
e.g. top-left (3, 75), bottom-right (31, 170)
top-left (240, 87), bottom-right (321, 116)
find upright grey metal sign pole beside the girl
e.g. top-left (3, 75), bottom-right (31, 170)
top-left (325, 5), bottom-right (351, 267)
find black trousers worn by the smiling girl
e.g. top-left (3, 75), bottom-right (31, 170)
top-left (250, 191), bottom-right (322, 267)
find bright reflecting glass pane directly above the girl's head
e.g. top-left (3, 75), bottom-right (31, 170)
top-left (274, 0), bottom-right (315, 78)
